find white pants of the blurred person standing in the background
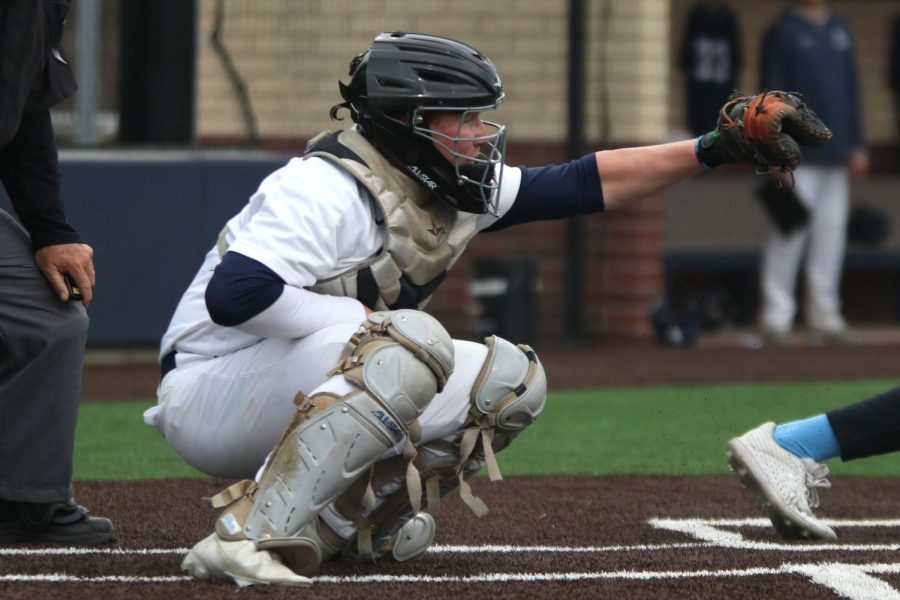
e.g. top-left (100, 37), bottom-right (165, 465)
top-left (762, 164), bottom-right (850, 332)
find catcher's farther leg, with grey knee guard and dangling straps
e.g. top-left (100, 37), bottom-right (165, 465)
top-left (320, 337), bottom-right (546, 561)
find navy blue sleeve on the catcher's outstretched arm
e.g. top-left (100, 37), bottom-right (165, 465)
top-left (485, 153), bottom-right (603, 231)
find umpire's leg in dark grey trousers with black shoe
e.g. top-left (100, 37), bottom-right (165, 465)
top-left (0, 210), bottom-right (113, 544)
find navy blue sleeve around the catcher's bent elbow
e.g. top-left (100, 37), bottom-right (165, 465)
top-left (206, 252), bottom-right (284, 327)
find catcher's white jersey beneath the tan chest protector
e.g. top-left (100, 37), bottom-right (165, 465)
top-left (160, 157), bottom-right (521, 365)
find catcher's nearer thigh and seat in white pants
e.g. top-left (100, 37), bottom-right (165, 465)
top-left (145, 324), bottom-right (358, 479)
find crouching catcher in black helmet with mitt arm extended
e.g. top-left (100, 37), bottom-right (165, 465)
top-left (145, 33), bottom-right (829, 586)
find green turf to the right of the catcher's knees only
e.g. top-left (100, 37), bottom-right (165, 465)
top-left (498, 380), bottom-right (900, 475)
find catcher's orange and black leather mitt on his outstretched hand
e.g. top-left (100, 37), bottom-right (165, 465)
top-left (697, 91), bottom-right (831, 172)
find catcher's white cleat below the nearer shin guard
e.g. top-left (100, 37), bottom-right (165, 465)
top-left (181, 533), bottom-right (312, 587)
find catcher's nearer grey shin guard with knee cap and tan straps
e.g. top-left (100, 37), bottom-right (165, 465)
top-left (217, 310), bottom-right (453, 572)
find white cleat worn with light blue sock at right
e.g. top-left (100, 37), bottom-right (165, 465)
top-left (728, 422), bottom-right (837, 540)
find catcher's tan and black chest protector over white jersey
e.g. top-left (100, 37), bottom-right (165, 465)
top-left (306, 130), bottom-right (478, 311)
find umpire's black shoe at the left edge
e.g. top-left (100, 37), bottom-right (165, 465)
top-left (0, 502), bottom-right (116, 546)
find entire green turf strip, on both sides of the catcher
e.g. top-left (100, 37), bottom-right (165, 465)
top-left (75, 380), bottom-right (900, 480)
